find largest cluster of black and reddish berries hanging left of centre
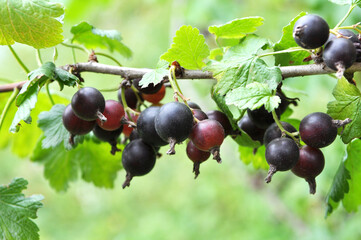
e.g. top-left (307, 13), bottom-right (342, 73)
top-left (63, 79), bottom-right (232, 188)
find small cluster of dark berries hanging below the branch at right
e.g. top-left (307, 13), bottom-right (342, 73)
top-left (238, 104), bottom-right (349, 194)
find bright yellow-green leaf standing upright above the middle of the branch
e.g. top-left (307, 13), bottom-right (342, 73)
top-left (160, 26), bottom-right (209, 69)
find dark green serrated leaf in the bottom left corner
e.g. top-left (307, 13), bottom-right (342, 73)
top-left (0, 178), bottom-right (43, 240)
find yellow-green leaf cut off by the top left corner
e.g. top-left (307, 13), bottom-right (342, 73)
top-left (0, 0), bottom-right (64, 49)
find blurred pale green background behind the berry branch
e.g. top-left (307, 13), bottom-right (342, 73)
top-left (0, 0), bottom-right (361, 240)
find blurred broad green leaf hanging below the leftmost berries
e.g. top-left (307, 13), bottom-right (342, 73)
top-left (31, 139), bottom-right (121, 191)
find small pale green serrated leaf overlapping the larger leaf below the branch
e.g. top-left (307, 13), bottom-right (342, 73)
top-left (226, 82), bottom-right (281, 112)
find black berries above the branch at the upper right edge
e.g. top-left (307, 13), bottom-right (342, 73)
top-left (293, 14), bottom-right (361, 76)
